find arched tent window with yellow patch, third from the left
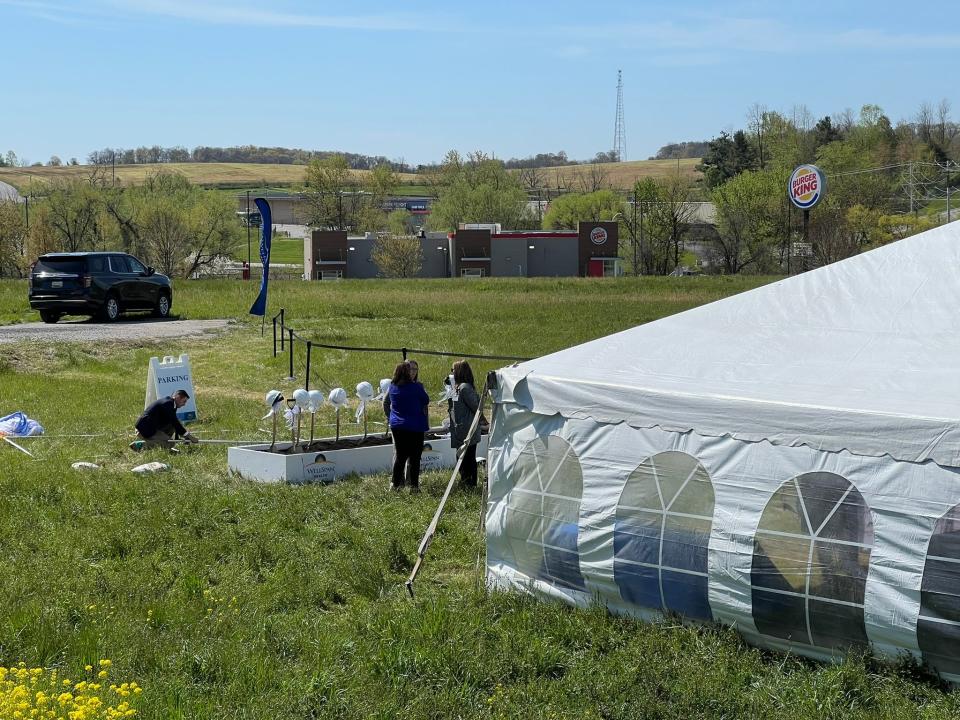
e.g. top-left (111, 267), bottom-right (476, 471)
top-left (750, 472), bottom-right (873, 649)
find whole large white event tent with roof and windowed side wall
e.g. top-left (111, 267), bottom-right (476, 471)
top-left (486, 223), bottom-right (960, 681)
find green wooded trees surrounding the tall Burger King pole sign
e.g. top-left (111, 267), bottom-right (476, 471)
top-left (699, 100), bottom-right (960, 273)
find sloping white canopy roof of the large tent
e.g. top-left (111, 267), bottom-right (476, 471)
top-left (498, 222), bottom-right (960, 467)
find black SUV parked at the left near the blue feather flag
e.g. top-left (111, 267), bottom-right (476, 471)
top-left (30, 252), bottom-right (173, 323)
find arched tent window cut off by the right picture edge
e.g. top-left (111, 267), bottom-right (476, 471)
top-left (917, 505), bottom-right (960, 675)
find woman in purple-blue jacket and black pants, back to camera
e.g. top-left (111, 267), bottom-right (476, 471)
top-left (383, 361), bottom-right (430, 493)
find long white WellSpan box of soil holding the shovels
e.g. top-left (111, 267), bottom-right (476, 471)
top-left (227, 435), bottom-right (487, 485)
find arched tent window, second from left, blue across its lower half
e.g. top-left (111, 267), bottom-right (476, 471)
top-left (613, 452), bottom-right (714, 620)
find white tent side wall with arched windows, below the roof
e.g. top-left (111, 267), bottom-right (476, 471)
top-left (486, 403), bottom-right (960, 679)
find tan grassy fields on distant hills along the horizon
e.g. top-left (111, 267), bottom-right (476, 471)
top-left (0, 158), bottom-right (700, 191)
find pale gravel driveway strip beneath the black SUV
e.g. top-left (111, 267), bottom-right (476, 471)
top-left (0, 319), bottom-right (232, 343)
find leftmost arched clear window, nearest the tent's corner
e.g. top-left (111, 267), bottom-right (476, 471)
top-left (504, 435), bottom-right (584, 590)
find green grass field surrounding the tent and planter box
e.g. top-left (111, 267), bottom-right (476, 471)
top-left (0, 277), bottom-right (960, 720)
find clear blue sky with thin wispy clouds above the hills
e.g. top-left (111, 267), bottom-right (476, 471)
top-left (0, 0), bottom-right (960, 163)
